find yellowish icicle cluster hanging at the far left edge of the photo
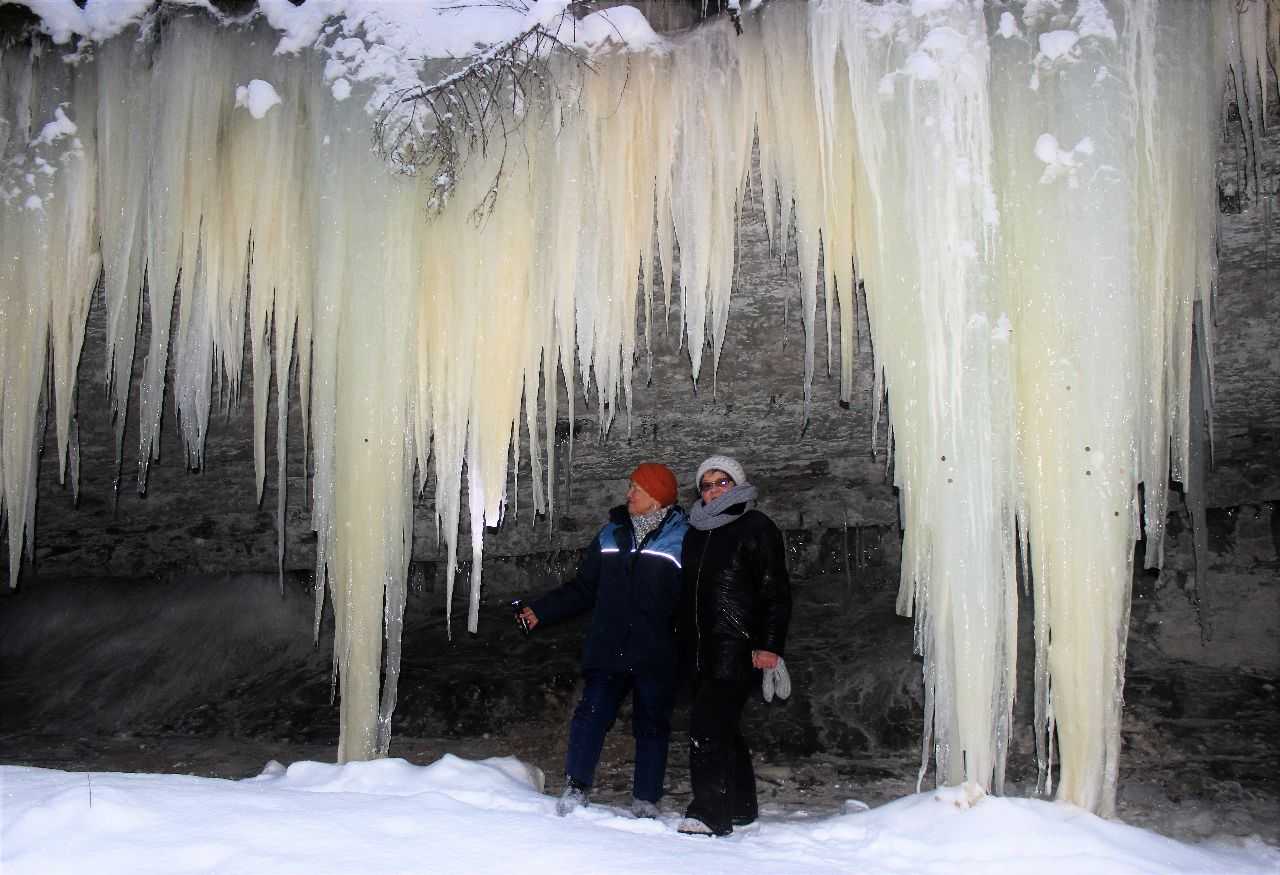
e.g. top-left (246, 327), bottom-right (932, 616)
top-left (0, 44), bottom-right (101, 586)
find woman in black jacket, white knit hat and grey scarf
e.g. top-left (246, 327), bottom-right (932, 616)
top-left (677, 455), bottom-right (791, 835)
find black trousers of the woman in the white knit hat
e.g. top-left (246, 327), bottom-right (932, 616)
top-left (685, 677), bottom-right (758, 834)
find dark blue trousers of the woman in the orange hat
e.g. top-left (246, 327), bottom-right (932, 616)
top-left (564, 672), bottom-right (675, 802)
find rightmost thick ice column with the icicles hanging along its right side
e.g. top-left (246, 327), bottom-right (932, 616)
top-left (996, 0), bottom-right (1216, 814)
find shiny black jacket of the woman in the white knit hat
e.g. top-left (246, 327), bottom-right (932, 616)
top-left (680, 505), bottom-right (791, 681)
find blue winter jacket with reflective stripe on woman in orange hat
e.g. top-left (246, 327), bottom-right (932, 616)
top-left (529, 505), bottom-right (689, 674)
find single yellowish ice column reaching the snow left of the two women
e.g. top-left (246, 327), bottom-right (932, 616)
top-left (315, 109), bottom-right (421, 761)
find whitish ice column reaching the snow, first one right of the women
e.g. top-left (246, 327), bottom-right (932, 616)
top-left (814, 3), bottom-right (1016, 788)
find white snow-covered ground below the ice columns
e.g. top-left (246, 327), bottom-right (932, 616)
top-left (0, 755), bottom-right (1280, 875)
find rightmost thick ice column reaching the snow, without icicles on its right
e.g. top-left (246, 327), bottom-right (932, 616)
top-left (997, 4), bottom-right (1139, 811)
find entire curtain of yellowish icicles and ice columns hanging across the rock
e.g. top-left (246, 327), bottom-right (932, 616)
top-left (0, 0), bottom-right (1276, 812)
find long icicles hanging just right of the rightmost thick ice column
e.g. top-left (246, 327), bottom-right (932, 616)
top-left (1126, 3), bottom-right (1228, 568)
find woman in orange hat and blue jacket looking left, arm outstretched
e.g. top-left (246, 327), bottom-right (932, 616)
top-left (521, 462), bottom-right (689, 817)
